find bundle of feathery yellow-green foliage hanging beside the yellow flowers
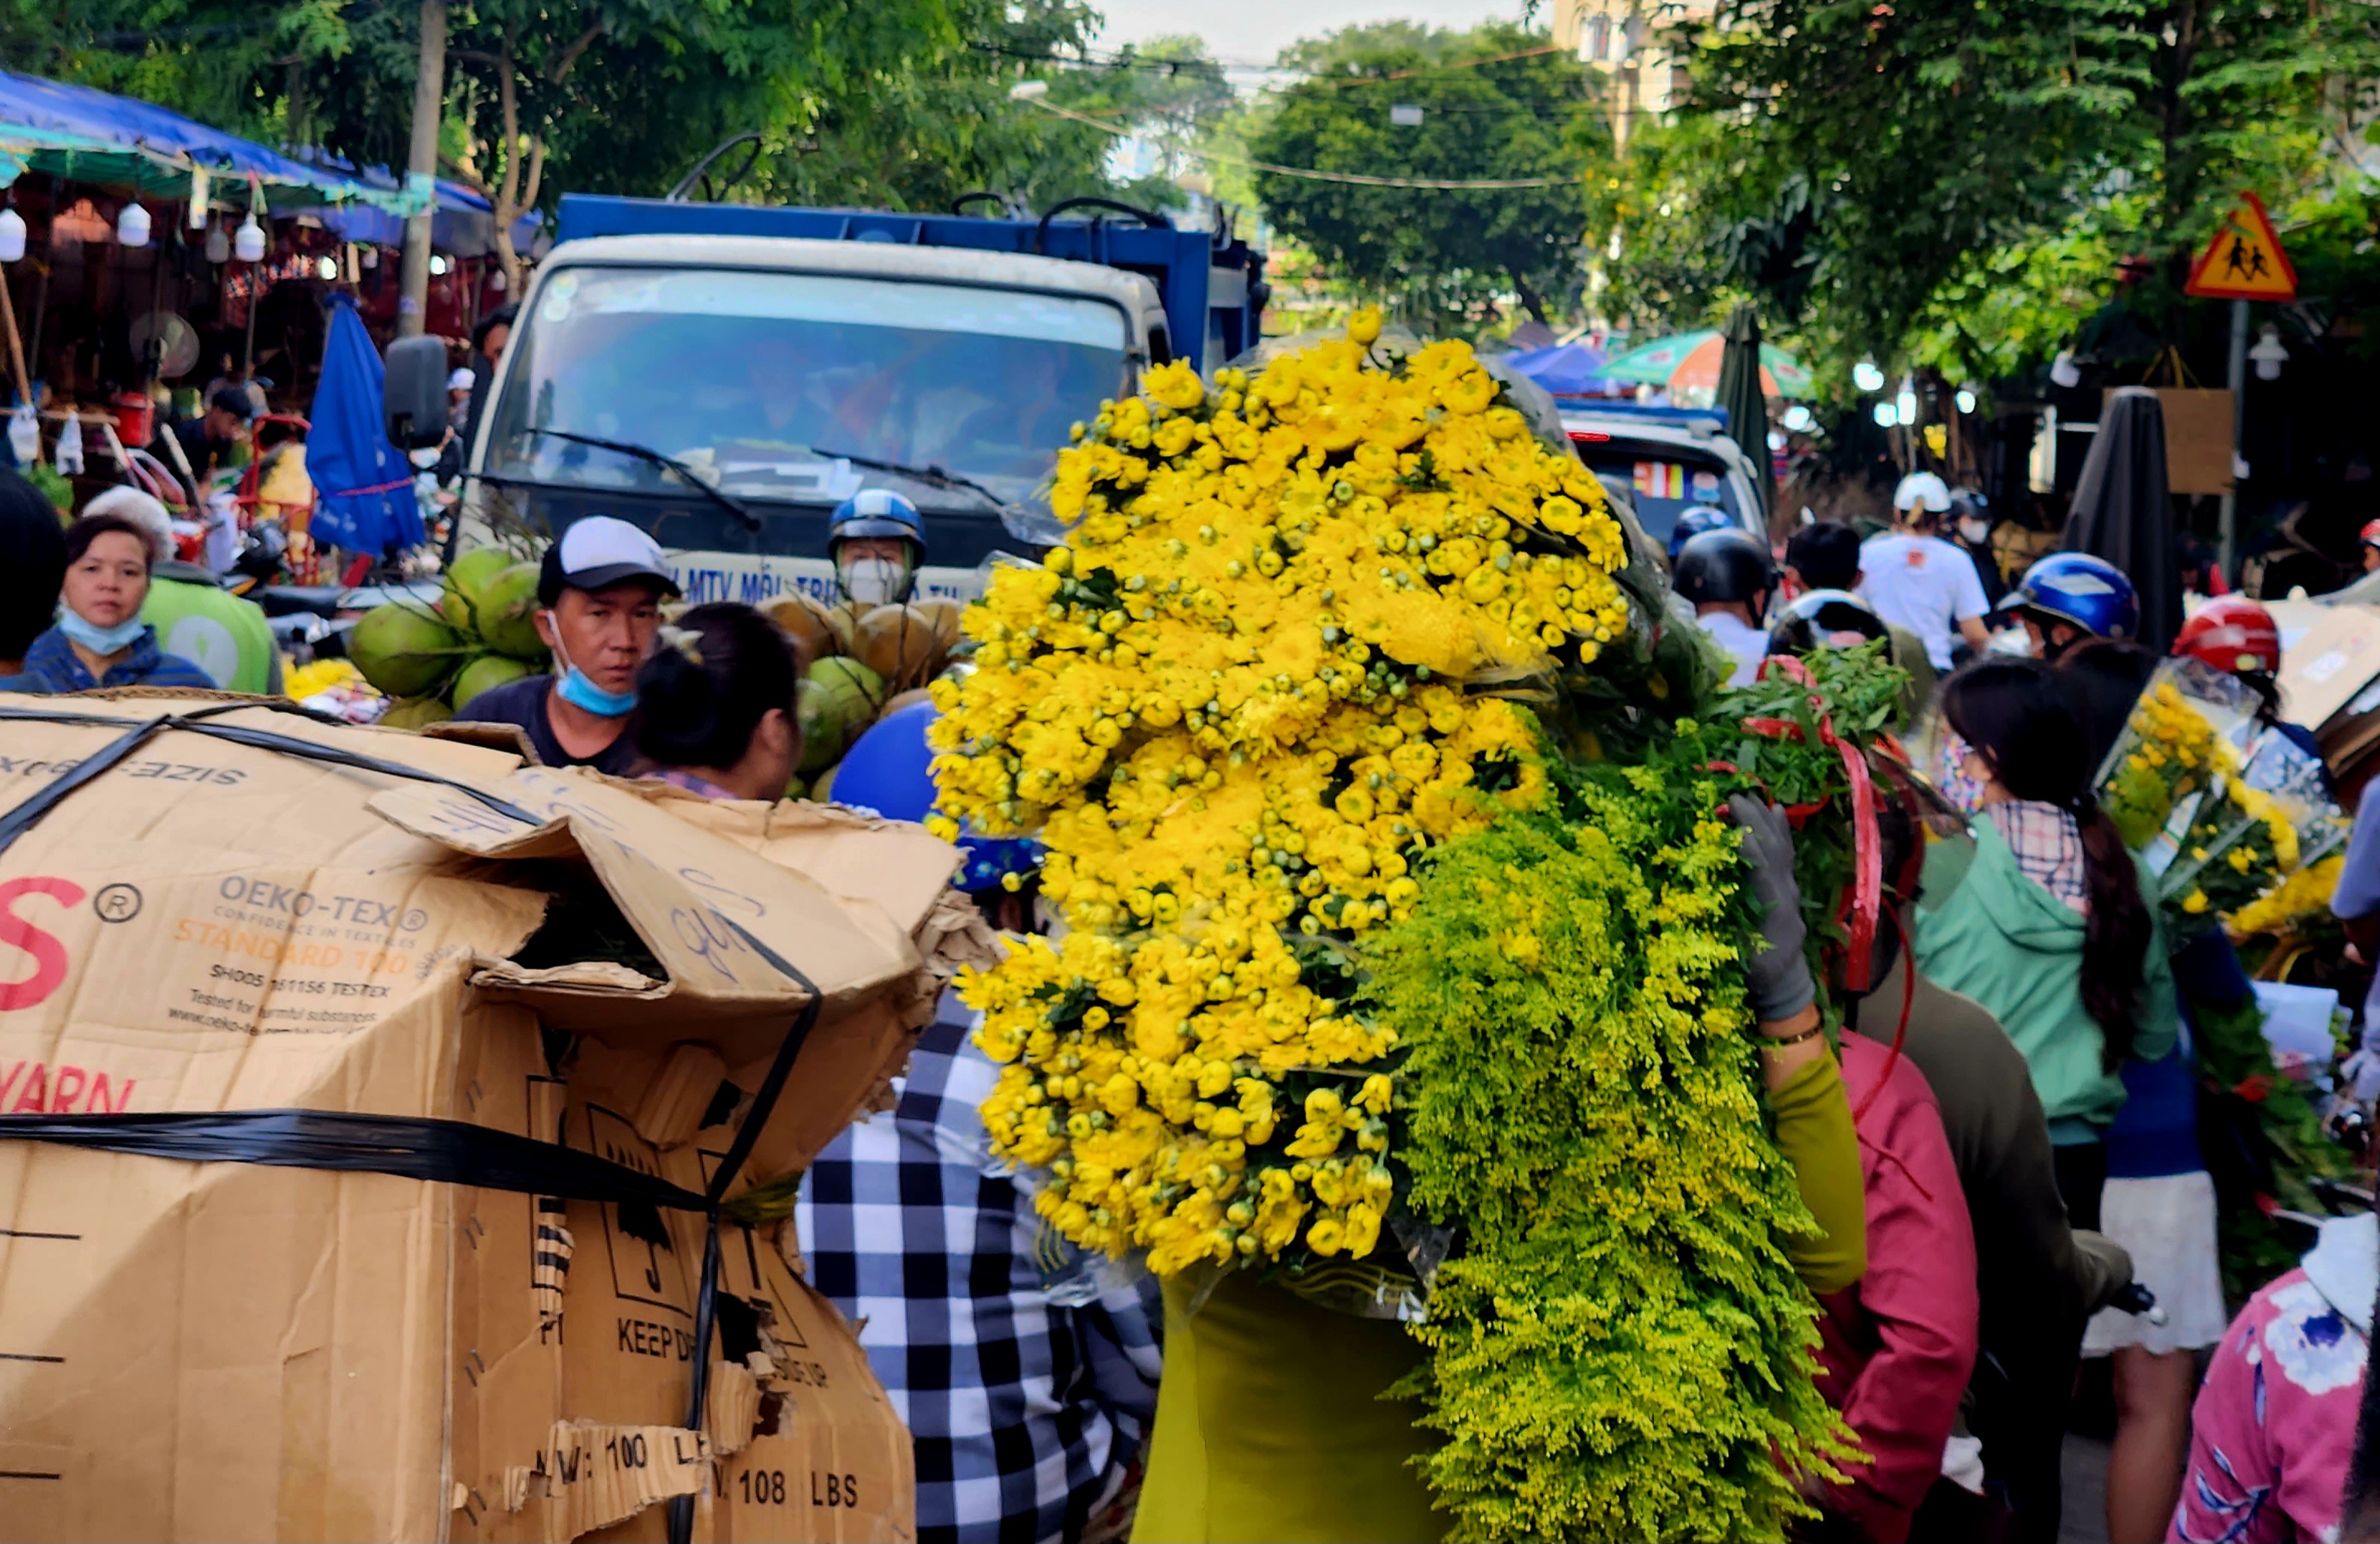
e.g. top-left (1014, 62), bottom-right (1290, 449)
top-left (1364, 709), bottom-right (1889, 1539)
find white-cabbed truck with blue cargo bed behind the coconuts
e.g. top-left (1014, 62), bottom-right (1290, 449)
top-left (447, 198), bottom-right (1264, 602)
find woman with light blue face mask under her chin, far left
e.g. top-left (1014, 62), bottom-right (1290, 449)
top-left (10, 514), bottom-right (214, 692)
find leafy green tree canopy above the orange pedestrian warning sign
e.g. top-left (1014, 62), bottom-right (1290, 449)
top-left (1592, 0), bottom-right (2380, 376)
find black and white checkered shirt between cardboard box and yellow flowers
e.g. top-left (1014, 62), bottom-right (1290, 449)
top-left (795, 997), bottom-right (1164, 1544)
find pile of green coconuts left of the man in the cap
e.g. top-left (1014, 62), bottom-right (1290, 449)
top-left (348, 547), bottom-right (548, 728)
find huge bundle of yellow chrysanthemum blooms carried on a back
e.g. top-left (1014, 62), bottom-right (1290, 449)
top-left (933, 314), bottom-right (1630, 1275)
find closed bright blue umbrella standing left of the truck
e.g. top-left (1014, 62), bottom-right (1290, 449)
top-left (305, 295), bottom-right (426, 557)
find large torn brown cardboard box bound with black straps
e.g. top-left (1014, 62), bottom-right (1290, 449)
top-left (0, 695), bottom-right (964, 1539)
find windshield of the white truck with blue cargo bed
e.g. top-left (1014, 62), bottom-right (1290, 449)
top-left (483, 269), bottom-right (1125, 509)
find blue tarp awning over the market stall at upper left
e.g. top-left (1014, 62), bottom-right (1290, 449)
top-left (0, 71), bottom-right (426, 214)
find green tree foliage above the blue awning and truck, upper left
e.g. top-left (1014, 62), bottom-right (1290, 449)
top-left (0, 0), bottom-right (1228, 225)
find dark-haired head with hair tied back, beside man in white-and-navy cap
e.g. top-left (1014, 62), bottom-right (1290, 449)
top-left (636, 602), bottom-right (802, 804)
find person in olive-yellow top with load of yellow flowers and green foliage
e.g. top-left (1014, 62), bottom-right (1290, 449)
top-left (929, 314), bottom-right (1880, 1539)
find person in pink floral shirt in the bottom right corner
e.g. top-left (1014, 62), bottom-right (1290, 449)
top-left (2166, 1213), bottom-right (2380, 1544)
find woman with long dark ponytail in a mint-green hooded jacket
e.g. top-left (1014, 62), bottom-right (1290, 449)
top-left (1916, 659), bottom-right (2178, 1228)
